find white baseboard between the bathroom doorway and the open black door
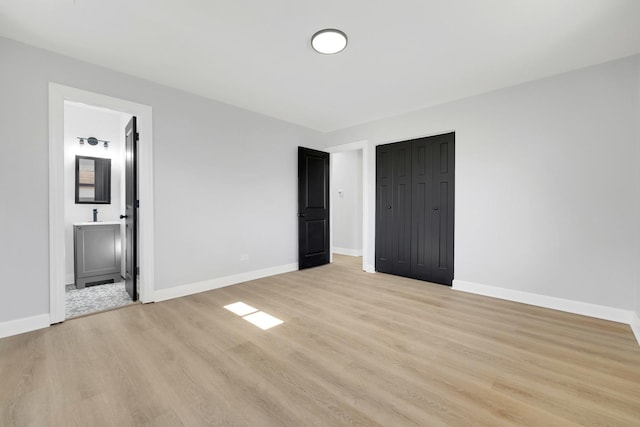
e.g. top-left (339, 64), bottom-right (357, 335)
top-left (154, 263), bottom-right (298, 302)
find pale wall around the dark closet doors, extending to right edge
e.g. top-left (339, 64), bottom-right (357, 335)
top-left (326, 56), bottom-right (640, 310)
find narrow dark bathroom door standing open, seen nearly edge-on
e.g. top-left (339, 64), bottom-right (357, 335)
top-left (121, 116), bottom-right (138, 301)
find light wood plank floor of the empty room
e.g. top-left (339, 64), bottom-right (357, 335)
top-left (0, 256), bottom-right (640, 427)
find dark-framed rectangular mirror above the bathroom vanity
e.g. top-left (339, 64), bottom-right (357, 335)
top-left (76, 156), bottom-right (111, 204)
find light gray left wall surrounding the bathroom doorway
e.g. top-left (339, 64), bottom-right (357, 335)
top-left (0, 38), bottom-right (321, 323)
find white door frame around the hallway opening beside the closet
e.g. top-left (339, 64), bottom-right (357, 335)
top-left (327, 140), bottom-right (375, 273)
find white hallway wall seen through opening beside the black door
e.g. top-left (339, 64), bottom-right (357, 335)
top-left (331, 150), bottom-right (362, 256)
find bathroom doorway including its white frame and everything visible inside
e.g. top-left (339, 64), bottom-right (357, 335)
top-left (49, 83), bottom-right (153, 324)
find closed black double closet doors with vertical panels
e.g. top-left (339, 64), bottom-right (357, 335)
top-left (376, 133), bottom-right (455, 285)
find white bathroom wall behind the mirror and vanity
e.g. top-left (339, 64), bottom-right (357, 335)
top-left (64, 102), bottom-right (130, 284)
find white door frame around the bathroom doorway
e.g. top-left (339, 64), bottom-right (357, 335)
top-left (49, 83), bottom-right (155, 324)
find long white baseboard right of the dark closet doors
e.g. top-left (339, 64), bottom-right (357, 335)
top-left (452, 279), bottom-right (635, 325)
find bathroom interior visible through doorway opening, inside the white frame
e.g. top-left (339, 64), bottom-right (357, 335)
top-left (64, 101), bottom-right (137, 319)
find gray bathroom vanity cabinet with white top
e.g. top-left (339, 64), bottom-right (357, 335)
top-left (73, 222), bottom-right (122, 289)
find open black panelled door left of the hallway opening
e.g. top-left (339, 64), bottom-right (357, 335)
top-left (298, 147), bottom-right (329, 269)
